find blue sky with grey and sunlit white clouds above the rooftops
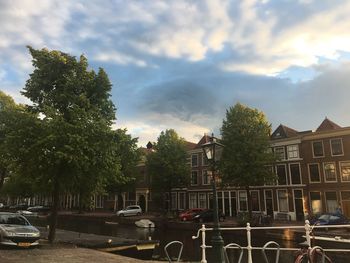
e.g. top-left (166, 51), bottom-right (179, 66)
top-left (0, 0), bottom-right (350, 146)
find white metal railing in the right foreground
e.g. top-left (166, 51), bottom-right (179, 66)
top-left (192, 220), bottom-right (350, 263)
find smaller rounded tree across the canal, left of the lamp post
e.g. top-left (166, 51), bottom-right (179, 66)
top-left (146, 129), bottom-right (190, 214)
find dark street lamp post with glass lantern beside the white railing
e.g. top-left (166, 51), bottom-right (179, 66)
top-left (202, 134), bottom-right (225, 263)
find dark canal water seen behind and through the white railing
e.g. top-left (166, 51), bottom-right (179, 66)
top-left (31, 219), bottom-right (350, 263)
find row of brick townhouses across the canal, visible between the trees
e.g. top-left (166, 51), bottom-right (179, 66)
top-left (135, 118), bottom-right (350, 220)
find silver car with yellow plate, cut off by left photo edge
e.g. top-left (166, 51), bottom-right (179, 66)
top-left (0, 212), bottom-right (40, 247)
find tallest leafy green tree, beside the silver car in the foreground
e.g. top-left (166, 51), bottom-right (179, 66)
top-left (7, 47), bottom-right (123, 242)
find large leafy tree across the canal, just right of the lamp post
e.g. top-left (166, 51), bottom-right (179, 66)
top-left (221, 103), bottom-right (275, 219)
